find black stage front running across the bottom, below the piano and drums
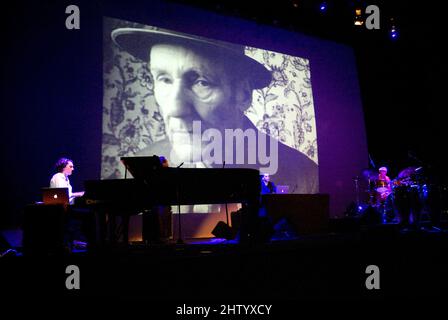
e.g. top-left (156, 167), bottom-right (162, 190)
top-left (0, 224), bottom-right (448, 319)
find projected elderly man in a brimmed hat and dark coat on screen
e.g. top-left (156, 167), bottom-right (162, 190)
top-left (112, 28), bottom-right (318, 193)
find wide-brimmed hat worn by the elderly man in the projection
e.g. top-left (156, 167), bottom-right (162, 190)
top-left (111, 28), bottom-right (271, 89)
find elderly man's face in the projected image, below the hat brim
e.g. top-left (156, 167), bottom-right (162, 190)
top-left (150, 44), bottom-right (242, 161)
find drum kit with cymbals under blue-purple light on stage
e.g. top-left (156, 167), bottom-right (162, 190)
top-left (356, 167), bottom-right (427, 223)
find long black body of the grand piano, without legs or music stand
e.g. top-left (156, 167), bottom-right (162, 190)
top-left (84, 168), bottom-right (261, 207)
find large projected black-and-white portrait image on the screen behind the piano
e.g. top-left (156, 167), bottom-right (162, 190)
top-left (101, 18), bottom-right (319, 193)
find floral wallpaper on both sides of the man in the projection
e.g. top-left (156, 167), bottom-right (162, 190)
top-left (101, 18), bottom-right (318, 179)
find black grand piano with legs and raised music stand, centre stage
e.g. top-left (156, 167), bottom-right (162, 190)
top-left (78, 156), bottom-right (260, 242)
